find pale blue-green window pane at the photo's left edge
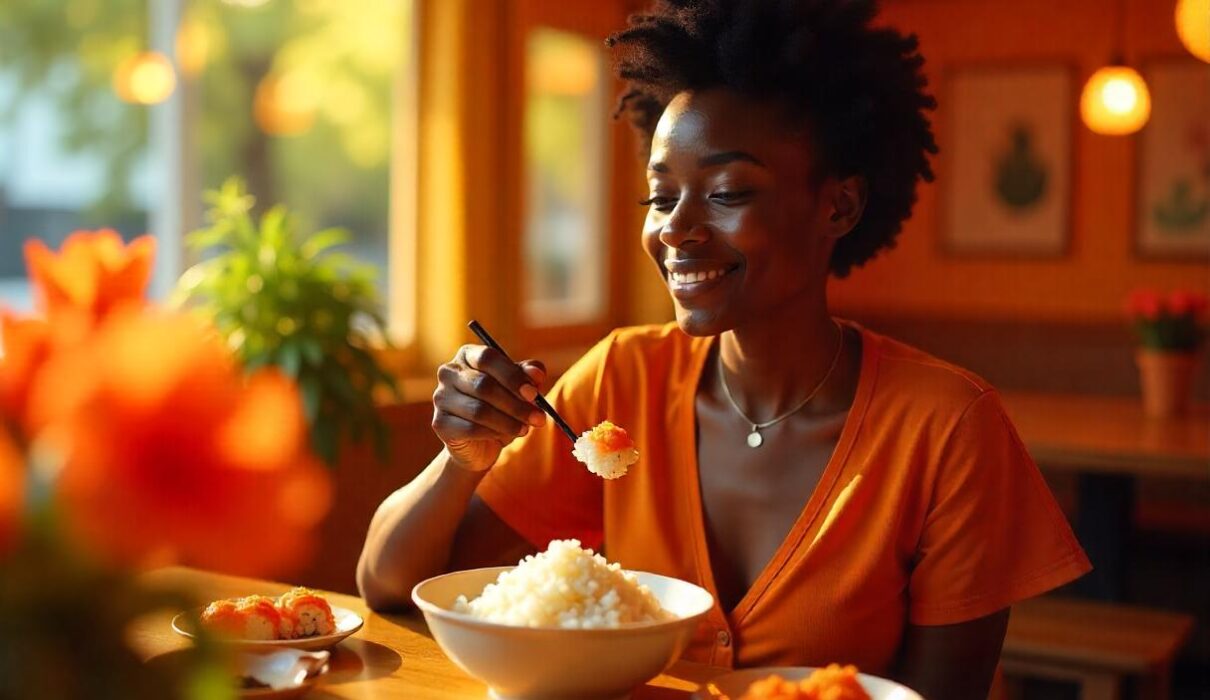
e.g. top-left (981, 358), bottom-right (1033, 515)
top-left (0, 0), bottom-right (161, 311)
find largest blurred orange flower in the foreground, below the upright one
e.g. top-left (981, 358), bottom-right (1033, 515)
top-left (42, 312), bottom-right (330, 575)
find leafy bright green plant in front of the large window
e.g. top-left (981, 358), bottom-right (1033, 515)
top-left (178, 178), bottom-right (398, 464)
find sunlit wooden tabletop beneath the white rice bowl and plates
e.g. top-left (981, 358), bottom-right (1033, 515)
top-left (131, 568), bottom-right (726, 700)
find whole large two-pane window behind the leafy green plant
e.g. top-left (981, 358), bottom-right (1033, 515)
top-left (0, 0), bottom-right (414, 339)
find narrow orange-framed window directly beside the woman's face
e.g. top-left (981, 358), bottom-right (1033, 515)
top-left (502, 0), bottom-right (643, 368)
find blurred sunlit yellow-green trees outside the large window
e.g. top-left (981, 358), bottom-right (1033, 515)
top-left (0, 0), bottom-right (411, 278)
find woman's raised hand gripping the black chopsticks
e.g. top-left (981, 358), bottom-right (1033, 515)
top-left (433, 345), bottom-right (546, 472)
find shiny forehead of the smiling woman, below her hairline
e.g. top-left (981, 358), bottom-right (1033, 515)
top-left (651, 88), bottom-right (808, 164)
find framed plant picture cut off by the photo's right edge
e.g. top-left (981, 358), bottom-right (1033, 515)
top-left (1135, 59), bottom-right (1210, 260)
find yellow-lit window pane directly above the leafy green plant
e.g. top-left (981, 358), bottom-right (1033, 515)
top-left (187, 0), bottom-right (407, 316)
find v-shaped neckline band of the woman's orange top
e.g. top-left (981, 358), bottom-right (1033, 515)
top-left (673, 322), bottom-right (877, 625)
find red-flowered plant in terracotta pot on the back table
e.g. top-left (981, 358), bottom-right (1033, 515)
top-left (1127, 289), bottom-right (1206, 417)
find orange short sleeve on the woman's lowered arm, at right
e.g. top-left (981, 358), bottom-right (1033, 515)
top-left (909, 391), bottom-right (1091, 625)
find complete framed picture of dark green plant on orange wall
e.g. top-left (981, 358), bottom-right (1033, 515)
top-left (940, 63), bottom-right (1073, 256)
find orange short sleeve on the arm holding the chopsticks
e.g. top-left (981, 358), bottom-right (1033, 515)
top-left (467, 335), bottom-right (613, 550)
